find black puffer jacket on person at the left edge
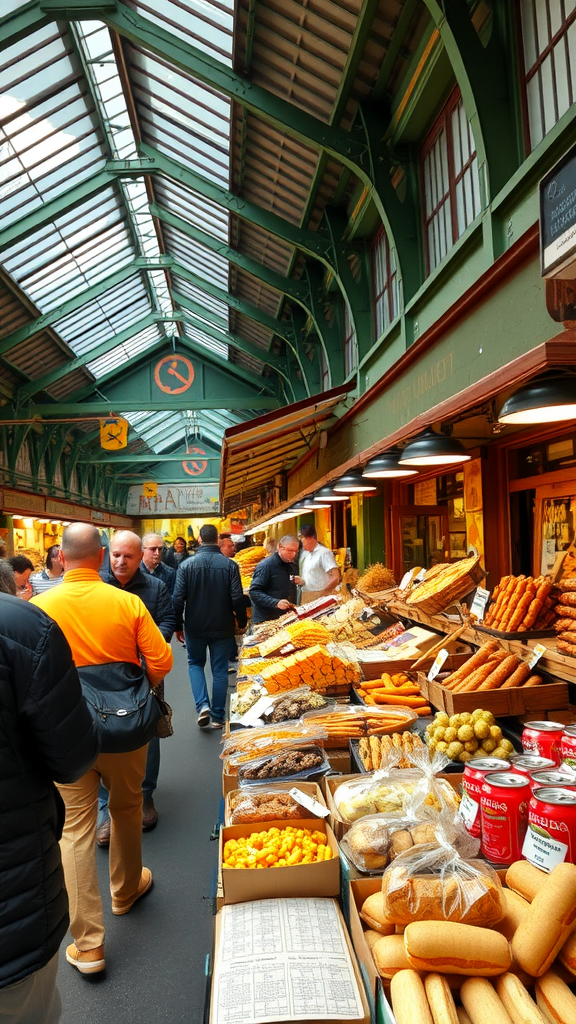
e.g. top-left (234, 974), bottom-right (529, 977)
top-left (0, 593), bottom-right (98, 988)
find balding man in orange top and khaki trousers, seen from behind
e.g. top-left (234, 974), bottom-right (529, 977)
top-left (33, 523), bottom-right (172, 974)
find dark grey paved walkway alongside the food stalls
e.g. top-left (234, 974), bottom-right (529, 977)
top-left (58, 640), bottom-right (224, 1024)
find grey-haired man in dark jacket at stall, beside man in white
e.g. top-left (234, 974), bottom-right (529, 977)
top-left (248, 535), bottom-right (299, 625)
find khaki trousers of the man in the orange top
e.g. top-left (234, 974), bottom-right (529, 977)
top-left (58, 744), bottom-right (148, 949)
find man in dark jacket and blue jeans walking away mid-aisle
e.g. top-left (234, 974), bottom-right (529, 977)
top-left (173, 525), bottom-right (246, 729)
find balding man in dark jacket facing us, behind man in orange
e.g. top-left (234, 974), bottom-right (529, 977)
top-left (96, 529), bottom-right (176, 846)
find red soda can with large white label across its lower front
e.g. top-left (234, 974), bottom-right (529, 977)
top-left (522, 785), bottom-right (576, 871)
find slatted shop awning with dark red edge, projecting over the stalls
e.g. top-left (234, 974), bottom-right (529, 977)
top-left (220, 382), bottom-right (355, 515)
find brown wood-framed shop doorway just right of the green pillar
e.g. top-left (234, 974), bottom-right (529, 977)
top-left (392, 505), bottom-right (450, 580)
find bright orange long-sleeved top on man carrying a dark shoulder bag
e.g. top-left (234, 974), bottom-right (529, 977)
top-left (32, 569), bottom-right (172, 683)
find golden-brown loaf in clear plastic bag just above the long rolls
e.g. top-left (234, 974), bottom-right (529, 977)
top-left (382, 862), bottom-right (505, 928)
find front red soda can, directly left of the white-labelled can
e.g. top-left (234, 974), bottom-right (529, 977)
top-left (480, 771), bottom-right (530, 867)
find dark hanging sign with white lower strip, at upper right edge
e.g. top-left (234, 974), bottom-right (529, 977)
top-left (540, 146), bottom-right (576, 278)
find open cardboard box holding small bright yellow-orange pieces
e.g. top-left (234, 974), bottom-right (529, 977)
top-left (218, 818), bottom-right (340, 904)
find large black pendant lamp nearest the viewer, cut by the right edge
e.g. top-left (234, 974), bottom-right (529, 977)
top-left (498, 374), bottom-right (576, 424)
